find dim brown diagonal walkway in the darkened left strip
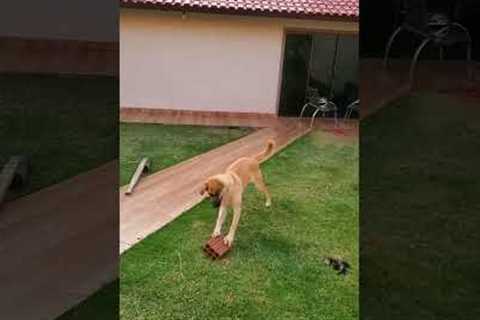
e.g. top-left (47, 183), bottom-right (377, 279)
top-left (0, 162), bottom-right (118, 320)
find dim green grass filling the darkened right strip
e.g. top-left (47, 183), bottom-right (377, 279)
top-left (360, 94), bottom-right (480, 320)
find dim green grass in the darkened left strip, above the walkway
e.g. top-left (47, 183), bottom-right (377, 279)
top-left (0, 75), bottom-right (118, 199)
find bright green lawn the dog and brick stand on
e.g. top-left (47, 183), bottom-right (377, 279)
top-left (120, 133), bottom-right (359, 320)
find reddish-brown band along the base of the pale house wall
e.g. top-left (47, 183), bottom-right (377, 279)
top-left (120, 107), bottom-right (278, 127)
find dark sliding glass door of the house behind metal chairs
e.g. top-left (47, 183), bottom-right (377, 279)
top-left (279, 33), bottom-right (358, 116)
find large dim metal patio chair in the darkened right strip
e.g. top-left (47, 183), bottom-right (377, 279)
top-left (384, 0), bottom-right (472, 86)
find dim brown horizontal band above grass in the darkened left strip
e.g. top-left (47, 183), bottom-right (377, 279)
top-left (0, 37), bottom-right (119, 76)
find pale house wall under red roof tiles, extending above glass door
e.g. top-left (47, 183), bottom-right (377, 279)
top-left (120, 9), bottom-right (357, 113)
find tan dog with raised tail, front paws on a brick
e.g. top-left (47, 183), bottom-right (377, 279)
top-left (200, 139), bottom-right (275, 246)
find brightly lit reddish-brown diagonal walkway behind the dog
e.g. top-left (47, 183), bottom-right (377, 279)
top-left (120, 119), bottom-right (309, 253)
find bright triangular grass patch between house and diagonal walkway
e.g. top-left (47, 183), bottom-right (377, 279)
top-left (120, 123), bottom-right (252, 186)
